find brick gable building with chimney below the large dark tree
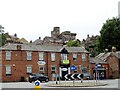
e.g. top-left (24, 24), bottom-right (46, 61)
top-left (96, 47), bottom-right (120, 78)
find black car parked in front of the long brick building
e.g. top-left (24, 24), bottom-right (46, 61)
top-left (29, 74), bottom-right (49, 83)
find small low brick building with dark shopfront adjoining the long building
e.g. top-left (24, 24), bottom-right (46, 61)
top-left (90, 58), bottom-right (109, 79)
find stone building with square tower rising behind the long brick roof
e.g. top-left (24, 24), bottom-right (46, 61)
top-left (33, 27), bottom-right (77, 45)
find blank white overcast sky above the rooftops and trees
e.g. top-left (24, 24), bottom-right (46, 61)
top-left (0, 0), bottom-right (120, 41)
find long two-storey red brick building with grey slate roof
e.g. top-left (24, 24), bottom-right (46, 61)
top-left (0, 44), bottom-right (89, 82)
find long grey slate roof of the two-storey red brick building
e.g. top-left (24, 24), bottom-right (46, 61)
top-left (0, 44), bottom-right (89, 53)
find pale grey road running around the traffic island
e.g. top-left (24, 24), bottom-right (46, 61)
top-left (0, 79), bottom-right (120, 90)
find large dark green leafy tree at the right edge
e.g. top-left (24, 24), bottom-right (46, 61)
top-left (96, 18), bottom-right (120, 52)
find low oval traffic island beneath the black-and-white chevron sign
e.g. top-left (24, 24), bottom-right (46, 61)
top-left (47, 82), bottom-right (107, 87)
